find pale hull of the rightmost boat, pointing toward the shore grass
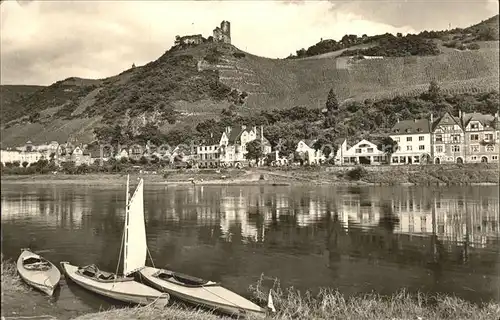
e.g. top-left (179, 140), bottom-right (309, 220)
top-left (138, 267), bottom-right (265, 316)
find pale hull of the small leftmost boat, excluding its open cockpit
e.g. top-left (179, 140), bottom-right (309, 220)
top-left (16, 249), bottom-right (61, 296)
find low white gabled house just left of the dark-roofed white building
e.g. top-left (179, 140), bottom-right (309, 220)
top-left (335, 139), bottom-right (387, 165)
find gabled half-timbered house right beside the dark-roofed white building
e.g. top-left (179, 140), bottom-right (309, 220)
top-left (432, 112), bottom-right (465, 164)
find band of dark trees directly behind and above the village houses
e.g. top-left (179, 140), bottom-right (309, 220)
top-left (96, 82), bottom-right (499, 155)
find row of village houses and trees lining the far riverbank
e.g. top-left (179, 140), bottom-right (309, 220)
top-left (1, 111), bottom-right (500, 168)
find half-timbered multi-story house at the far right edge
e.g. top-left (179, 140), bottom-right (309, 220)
top-left (461, 113), bottom-right (500, 163)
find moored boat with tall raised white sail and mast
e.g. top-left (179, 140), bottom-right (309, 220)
top-left (61, 176), bottom-right (170, 305)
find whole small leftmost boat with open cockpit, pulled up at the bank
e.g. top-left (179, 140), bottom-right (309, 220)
top-left (17, 249), bottom-right (61, 296)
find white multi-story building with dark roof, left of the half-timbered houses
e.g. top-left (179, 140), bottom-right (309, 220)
top-left (388, 119), bottom-right (432, 165)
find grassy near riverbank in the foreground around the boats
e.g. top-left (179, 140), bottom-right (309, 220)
top-left (2, 260), bottom-right (500, 320)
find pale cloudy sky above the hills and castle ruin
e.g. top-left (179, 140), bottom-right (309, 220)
top-left (0, 0), bottom-right (499, 85)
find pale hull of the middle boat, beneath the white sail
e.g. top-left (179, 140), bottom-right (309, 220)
top-left (61, 262), bottom-right (170, 305)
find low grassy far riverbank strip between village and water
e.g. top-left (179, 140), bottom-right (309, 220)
top-left (1, 164), bottom-right (500, 185)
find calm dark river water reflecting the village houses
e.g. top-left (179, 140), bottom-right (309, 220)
top-left (1, 184), bottom-right (500, 318)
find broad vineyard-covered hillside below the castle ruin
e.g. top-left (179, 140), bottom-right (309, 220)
top-left (1, 16), bottom-right (499, 145)
